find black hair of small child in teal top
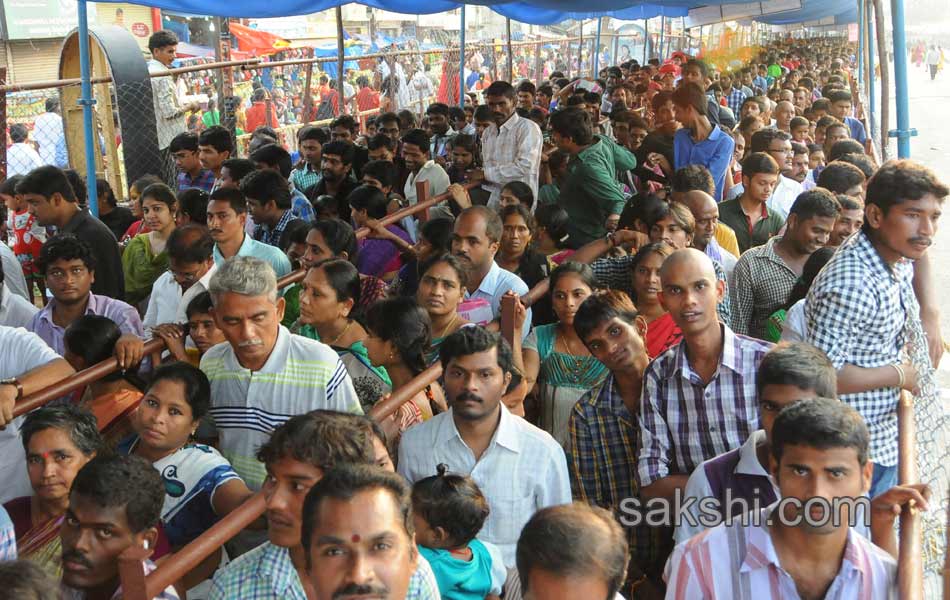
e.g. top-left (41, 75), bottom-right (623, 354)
top-left (412, 464), bottom-right (490, 548)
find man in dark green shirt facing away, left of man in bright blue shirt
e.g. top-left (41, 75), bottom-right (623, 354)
top-left (551, 108), bottom-right (637, 248)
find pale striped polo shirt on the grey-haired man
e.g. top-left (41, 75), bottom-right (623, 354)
top-left (201, 326), bottom-right (363, 490)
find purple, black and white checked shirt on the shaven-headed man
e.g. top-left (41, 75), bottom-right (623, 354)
top-left (637, 325), bottom-right (772, 487)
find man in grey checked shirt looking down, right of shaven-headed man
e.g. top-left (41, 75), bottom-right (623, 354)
top-left (730, 188), bottom-right (841, 339)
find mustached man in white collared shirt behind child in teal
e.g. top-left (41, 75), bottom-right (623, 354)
top-left (399, 326), bottom-right (571, 568)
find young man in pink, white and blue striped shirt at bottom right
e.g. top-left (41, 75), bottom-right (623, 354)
top-left (666, 398), bottom-right (930, 600)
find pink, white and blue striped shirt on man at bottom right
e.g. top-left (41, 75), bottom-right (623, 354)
top-left (665, 504), bottom-right (897, 600)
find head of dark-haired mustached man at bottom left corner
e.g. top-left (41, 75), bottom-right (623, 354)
top-left (59, 455), bottom-right (178, 600)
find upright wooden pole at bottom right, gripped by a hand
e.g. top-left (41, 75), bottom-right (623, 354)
top-left (897, 391), bottom-right (924, 600)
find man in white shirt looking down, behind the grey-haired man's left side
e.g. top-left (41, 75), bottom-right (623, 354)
top-left (142, 224), bottom-right (215, 335)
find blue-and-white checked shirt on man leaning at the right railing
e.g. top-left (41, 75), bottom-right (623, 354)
top-left (805, 231), bottom-right (920, 466)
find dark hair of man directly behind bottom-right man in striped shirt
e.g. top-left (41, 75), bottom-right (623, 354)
top-left (755, 342), bottom-right (837, 399)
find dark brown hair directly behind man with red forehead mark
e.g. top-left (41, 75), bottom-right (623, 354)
top-left (256, 410), bottom-right (376, 471)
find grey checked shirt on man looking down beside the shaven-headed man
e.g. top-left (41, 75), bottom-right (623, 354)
top-left (732, 237), bottom-right (798, 339)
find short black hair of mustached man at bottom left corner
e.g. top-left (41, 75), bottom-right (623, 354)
top-left (70, 454), bottom-right (165, 533)
